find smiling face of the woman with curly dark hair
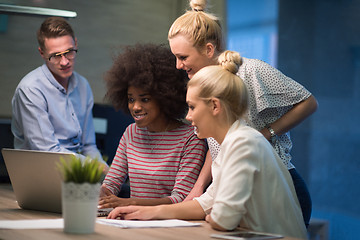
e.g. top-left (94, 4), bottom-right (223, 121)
top-left (128, 86), bottom-right (168, 132)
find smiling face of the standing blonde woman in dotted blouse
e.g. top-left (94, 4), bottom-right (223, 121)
top-left (169, 34), bottom-right (216, 79)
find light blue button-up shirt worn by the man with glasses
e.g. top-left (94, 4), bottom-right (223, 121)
top-left (11, 64), bottom-right (102, 161)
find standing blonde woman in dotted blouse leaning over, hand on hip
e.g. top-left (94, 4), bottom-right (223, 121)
top-left (168, 0), bottom-right (317, 225)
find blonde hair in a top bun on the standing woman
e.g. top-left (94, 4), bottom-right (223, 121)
top-left (168, 0), bottom-right (224, 52)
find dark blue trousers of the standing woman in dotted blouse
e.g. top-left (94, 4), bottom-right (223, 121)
top-left (289, 168), bottom-right (312, 227)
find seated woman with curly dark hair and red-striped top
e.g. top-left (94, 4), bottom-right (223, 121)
top-left (99, 44), bottom-right (206, 208)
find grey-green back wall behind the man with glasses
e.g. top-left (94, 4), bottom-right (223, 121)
top-left (0, 0), bottom-right (225, 118)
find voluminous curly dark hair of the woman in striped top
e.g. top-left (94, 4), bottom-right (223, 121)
top-left (104, 43), bottom-right (188, 119)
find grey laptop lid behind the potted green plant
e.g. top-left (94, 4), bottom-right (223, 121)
top-left (2, 148), bottom-right (73, 213)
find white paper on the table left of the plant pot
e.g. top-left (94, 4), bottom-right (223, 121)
top-left (0, 218), bottom-right (64, 229)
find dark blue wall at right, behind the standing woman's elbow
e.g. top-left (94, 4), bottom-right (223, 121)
top-left (278, 0), bottom-right (360, 240)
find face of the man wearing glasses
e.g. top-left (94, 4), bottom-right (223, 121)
top-left (39, 35), bottom-right (77, 85)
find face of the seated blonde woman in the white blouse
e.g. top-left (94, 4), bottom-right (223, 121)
top-left (186, 86), bottom-right (214, 138)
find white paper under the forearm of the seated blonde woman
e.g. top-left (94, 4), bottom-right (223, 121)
top-left (96, 219), bottom-right (201, 228)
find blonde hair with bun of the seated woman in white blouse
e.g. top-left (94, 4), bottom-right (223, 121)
top-left (188, 51), bottom-right (249, 124)
